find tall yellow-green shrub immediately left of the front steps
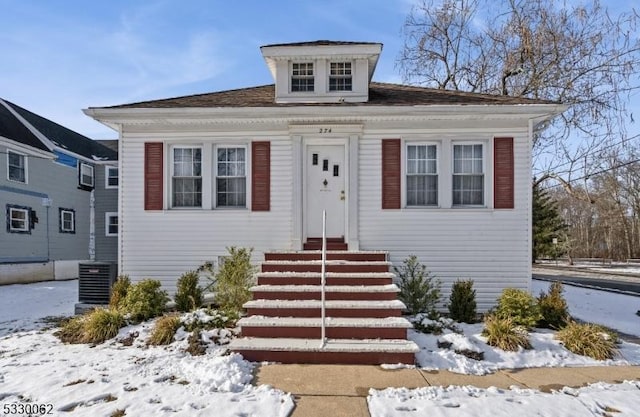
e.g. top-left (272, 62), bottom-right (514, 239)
top-left (208, 246), bottom-right (256, 312)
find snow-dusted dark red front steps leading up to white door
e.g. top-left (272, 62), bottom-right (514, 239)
top-left (230, 250), bottom-right (418, 364)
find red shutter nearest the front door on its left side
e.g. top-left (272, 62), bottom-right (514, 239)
top-left (251, 142), bottom-right (271, 211)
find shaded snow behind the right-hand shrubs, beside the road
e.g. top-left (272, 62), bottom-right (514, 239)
top-left (532, 279), bottom-right (640, 337)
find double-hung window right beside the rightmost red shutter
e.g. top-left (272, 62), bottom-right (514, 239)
top-left (453, 144), bottom-right (484, 206)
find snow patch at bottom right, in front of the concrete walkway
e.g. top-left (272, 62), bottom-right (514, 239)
top-left (367, 381), bottom-right (640, 417)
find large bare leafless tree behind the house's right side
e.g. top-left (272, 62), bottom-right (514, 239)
top-left (398, 0), bottom-right (640, 179)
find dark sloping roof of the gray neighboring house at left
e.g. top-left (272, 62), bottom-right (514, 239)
top-left (0, 100), bottom-right (118, 161)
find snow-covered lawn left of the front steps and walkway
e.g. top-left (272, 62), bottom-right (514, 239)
top-left (0, 281), bottom-right (293, 417)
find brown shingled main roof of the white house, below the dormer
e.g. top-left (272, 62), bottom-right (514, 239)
top-left (99, 82), bottom-right (557, 109)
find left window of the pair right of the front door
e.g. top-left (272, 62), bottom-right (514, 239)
top-left (407, 145), bottom-right (438, 206)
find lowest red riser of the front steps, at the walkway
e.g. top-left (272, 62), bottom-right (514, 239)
top-left (236, 350), bottom-right (415, 365)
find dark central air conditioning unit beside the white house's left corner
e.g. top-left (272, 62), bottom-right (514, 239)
top-left (78, 262), bottom-right (118, 305)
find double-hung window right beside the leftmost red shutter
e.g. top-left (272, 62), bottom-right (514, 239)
top-left (171, 147), bottom-right (202, 207)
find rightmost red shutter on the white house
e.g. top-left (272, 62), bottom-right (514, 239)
top-left (493, 138), bottom-right (514, 209)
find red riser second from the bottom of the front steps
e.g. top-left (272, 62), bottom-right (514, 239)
top-left (242, 326), bottom-right (407, 339)
